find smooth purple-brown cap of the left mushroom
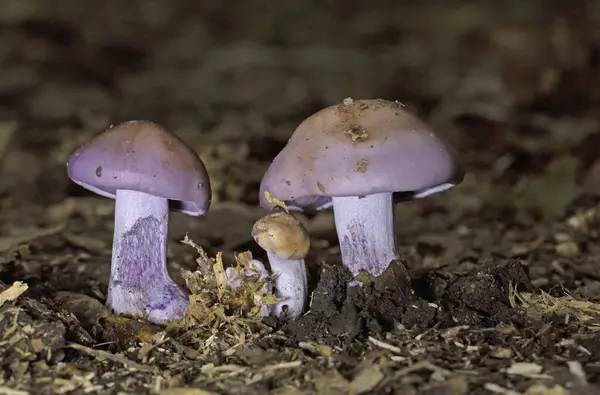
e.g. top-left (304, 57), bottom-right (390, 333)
top-left (67, 121), bottom-right (211, 215)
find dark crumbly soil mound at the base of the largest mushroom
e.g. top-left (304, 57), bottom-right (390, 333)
top-left (285, 261), bottom-right (533, 340)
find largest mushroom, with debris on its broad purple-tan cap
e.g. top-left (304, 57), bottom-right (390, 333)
top-left (260, 99), bottom-right (464, 277)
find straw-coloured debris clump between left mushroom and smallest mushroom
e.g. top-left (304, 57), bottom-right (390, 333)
top-left (167, 235), bottom-right (277, 355)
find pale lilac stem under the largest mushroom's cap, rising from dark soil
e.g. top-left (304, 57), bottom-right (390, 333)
top-left (332, 192), bottom-right (398, 277)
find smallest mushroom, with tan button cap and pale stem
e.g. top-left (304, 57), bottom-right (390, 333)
top-left (252, 212), bottom-right (310, 320)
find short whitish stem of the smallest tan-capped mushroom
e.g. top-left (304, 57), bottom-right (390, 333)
top-left (267, 251), bottom-right (308, 320)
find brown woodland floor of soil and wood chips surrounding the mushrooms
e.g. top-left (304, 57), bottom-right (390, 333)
top-left (0, 0), bottom-right (600, 395)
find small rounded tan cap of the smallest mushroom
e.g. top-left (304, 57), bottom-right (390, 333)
top-left (252, 212), bottom-right (310, 259)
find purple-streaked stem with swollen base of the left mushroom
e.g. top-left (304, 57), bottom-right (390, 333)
top-left (106, 190), bottom-right (189, 324)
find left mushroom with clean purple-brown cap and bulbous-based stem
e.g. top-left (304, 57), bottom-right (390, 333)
top-left (67, 121), bottom-right (211, 324)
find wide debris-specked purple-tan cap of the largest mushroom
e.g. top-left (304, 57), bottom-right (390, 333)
top-left (259, 99), bottom-right (464, 210)
